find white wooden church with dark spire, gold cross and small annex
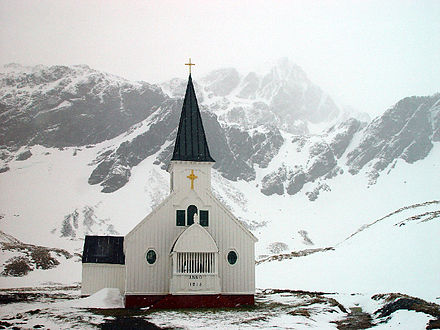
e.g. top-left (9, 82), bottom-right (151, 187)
top-left (81, 62), bottom-right (257, 308)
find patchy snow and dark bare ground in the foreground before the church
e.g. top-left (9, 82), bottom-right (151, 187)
top-left (0, 287), bottom-right (440, 329)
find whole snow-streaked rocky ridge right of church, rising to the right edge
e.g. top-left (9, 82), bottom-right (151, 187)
top-left (261, 94), bottom-right (440, 200)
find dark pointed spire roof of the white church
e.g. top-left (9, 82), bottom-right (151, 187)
top-left (171, 74), bottom-right (215, 162)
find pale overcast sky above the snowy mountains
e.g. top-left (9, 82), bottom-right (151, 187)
top-left (0, 0), bottom-right (440, 115)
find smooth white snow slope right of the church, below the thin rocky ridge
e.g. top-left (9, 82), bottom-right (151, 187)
top-left (256, 202), bottom-right (440, 303)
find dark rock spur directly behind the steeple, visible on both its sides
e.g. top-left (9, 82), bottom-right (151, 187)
top-left (89, 99), bottom-right (255, 192)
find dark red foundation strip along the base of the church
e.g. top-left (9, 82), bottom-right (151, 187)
top-left (125, 294), bottom-right (255, 309)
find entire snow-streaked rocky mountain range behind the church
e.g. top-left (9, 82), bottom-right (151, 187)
top-left (0, 59), bottom-right (440, 200)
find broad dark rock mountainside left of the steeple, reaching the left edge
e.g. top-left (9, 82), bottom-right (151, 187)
top-left (0, 66), bottom-right (165, 147)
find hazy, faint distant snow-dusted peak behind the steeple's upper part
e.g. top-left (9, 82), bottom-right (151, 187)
top-left (162, 58), bottom-right (342, 134)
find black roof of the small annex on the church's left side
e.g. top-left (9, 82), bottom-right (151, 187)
top-left (82, 236), bottom-right (125, 265)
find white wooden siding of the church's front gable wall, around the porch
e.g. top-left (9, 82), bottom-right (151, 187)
top-left (124, 162), bottom-right (256, 294)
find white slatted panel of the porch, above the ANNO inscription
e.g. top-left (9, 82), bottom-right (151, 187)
top-left (176, 252), bottom-right (215, 274)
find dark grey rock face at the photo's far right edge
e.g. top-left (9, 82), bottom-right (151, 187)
top-left (347, 94), bottom-right (440, 174)
